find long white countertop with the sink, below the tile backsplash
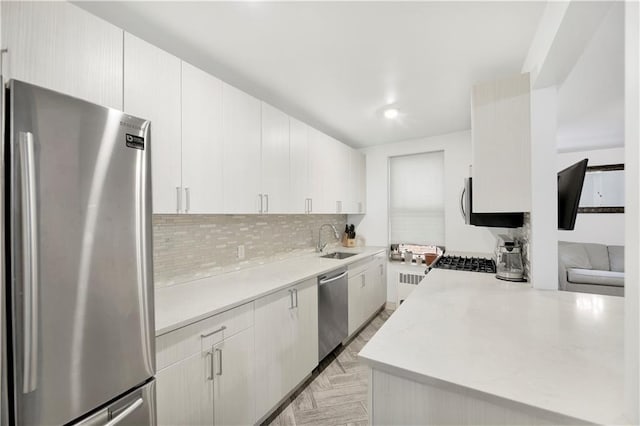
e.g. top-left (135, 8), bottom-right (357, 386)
top-left (155, 247), bottom-right (386, 336)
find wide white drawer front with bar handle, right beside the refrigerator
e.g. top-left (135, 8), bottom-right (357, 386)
top-left (156, 302), bottom-right (253, 371)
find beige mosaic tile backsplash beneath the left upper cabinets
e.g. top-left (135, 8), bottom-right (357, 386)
top-left (153, 214), bottom-right (347, 286)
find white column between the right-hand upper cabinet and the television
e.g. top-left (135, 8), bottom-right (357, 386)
top-left (529, 86), bottom-right (558, 290)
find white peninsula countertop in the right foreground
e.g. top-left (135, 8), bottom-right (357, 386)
top-left (359, 269), bottom-right (624, 424)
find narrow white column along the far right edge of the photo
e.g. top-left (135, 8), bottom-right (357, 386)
top-left (624, 1), bottom-right (640, 424)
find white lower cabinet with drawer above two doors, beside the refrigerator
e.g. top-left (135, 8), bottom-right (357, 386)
top-left (156, 303), bottom-right (256, 426)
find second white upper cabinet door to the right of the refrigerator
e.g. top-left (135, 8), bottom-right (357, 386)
top-left (182, 62), bottom-right (224, 214)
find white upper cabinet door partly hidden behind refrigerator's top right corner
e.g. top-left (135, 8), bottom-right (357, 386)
top-left (124, 33), bottom-right (184, 213)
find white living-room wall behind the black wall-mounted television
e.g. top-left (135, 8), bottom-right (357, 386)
top-left (557, 148), bottom-right (625, 245)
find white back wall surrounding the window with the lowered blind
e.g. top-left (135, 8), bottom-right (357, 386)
top-left (348, 131), bottom-right (507, 302)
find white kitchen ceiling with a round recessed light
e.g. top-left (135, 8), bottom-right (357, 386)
top-left (78, 1), bottom-right (544, 147)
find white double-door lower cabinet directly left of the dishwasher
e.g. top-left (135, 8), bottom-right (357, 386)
top-left (255, 278), bottom-right (318, 419)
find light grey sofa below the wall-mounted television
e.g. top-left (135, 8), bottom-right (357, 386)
top-left (558, 241), bottom-right (624, 296)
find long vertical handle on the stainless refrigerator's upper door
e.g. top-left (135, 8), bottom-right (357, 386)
top-left (19, 132), bottom-right (38, 393)
